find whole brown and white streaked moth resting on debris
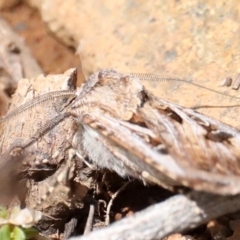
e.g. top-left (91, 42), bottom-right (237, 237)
top-left (0, 69), bottom-right (240, 195)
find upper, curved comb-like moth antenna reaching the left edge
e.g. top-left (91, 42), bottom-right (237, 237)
top-left (0, 90), bottom-right (75, 123)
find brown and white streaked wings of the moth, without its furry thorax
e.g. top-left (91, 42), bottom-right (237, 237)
top-left (78, 70), bottom-right (240, 194)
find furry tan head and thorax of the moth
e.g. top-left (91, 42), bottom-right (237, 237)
top-left (73, 69), bottom-right (144, 120)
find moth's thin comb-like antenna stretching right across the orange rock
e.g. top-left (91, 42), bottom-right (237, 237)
top-left (129, 73), bottom-right (240, 100)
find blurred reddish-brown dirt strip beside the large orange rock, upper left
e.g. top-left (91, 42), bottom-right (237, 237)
top-left (1, 4), bottom-right (83, 83)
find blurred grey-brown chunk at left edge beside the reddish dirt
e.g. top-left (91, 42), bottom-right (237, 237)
top-left (0, 17), bottom-right (42, 116)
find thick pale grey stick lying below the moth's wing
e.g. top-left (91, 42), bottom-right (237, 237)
top-left (70, 191), bottom-right (240, 240)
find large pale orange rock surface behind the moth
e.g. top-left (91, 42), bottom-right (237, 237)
top-left (22, 0), bottom-right (240, 127)
